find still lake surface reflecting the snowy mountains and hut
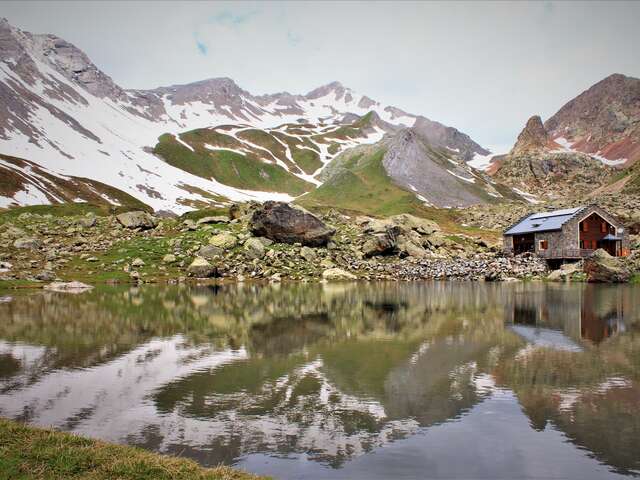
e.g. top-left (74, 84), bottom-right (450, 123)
top-left (0, 283), bottom-right (640, 479)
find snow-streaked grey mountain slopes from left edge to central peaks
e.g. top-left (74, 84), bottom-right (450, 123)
top-left (0, 19), bottom-right (486, 211)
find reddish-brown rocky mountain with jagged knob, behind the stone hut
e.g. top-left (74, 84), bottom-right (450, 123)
top-left (487, 74), bottom-right (640, 199)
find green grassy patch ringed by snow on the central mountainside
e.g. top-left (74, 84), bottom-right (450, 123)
top-left (154, 131), bottom-right (313, 195)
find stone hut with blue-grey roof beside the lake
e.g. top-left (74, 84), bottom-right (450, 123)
top-left (504, 205), bottom-right (629, 260)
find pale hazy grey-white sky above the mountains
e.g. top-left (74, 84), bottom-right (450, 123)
top-left (5, 1), bottom-right (640, 149)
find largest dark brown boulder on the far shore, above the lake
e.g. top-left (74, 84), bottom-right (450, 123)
top-left (249, 202), bottom-right (335, 247)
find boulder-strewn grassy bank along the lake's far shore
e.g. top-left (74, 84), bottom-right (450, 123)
top-left (0, 205), bottom-right (640, 289)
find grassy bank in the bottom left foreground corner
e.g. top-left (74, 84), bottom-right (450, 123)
top-left (0, 418), bottom-right (264, 480)
